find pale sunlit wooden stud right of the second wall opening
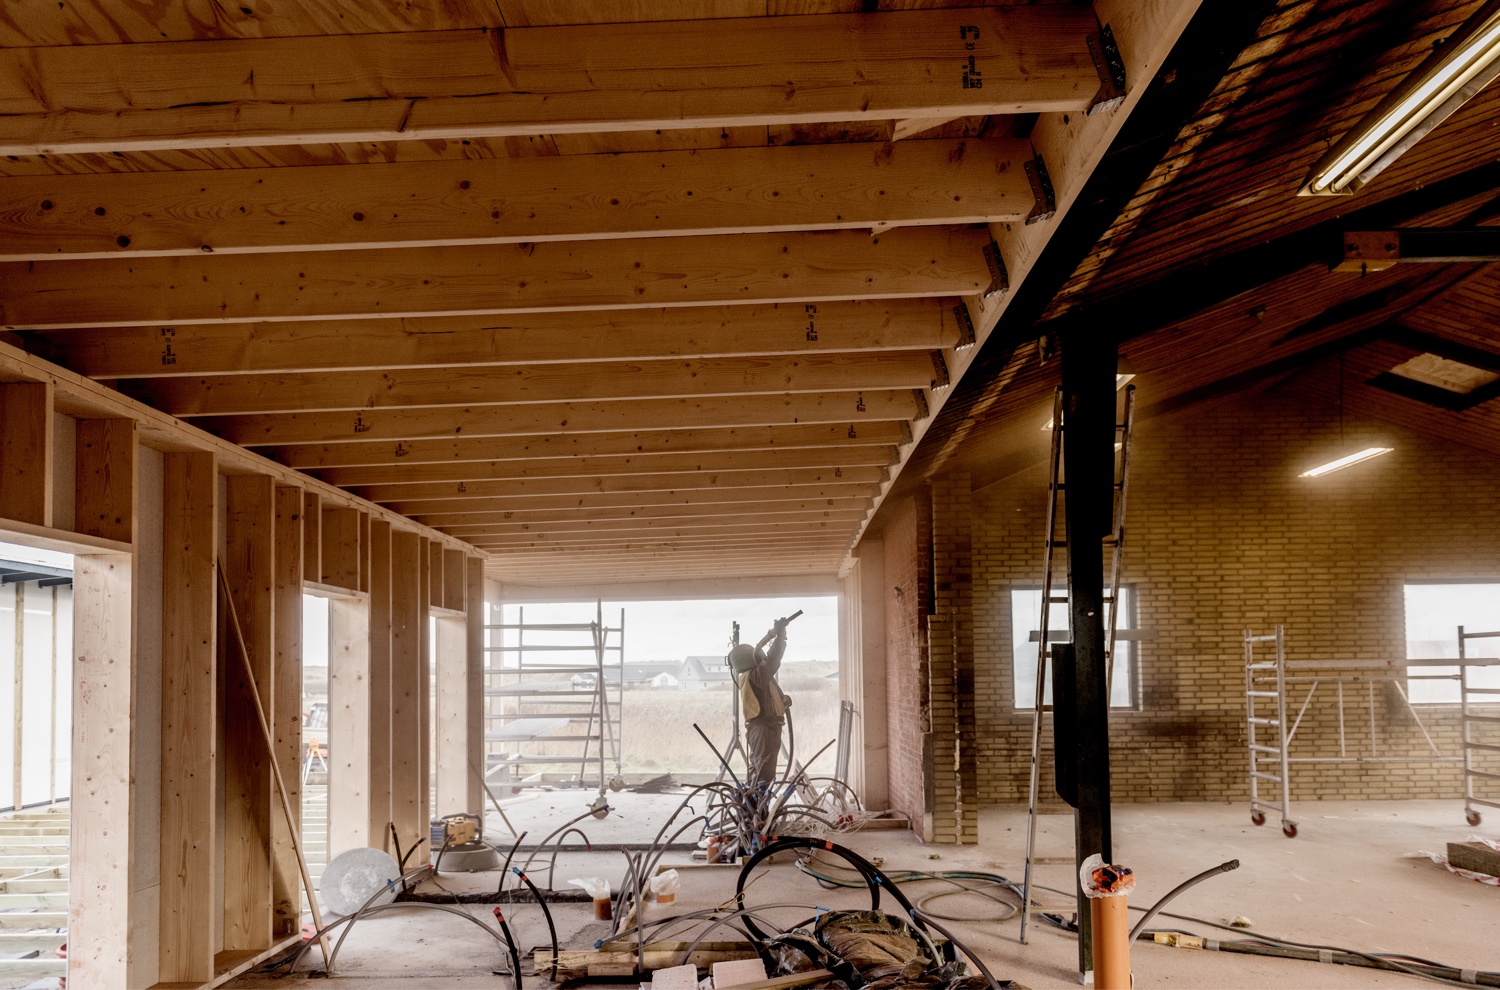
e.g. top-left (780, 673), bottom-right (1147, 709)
top-left (329, 599), bottom-right (372, 858)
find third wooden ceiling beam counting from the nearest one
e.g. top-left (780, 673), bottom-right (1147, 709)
top-left (0, 227), bottom-right (999, 330)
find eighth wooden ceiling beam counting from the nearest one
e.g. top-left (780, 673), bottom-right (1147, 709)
top-left (318, 447), bottom-right (897, 488)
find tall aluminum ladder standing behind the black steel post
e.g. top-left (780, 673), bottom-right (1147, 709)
top-left (1022, 386), bottom-right (1136, 945)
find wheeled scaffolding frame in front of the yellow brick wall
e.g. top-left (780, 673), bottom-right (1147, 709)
top-left (1244, 626), bottom-right (1500, 839)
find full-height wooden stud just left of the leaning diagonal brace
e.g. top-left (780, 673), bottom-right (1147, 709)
top-left (159, 453), bottom-right (219, 984)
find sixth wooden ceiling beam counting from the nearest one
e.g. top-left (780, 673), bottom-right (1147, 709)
top-left (205, 389), bottom-right (929, 447)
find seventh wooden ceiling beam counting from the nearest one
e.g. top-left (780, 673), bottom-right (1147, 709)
top-left (263, 420), bottom-right (912, 471)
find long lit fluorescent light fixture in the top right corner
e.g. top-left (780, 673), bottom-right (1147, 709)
top-left (1298, 0), bottom-right (1500, 197)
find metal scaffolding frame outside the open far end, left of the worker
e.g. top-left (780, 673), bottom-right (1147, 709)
top-left (485, 602), bottom-right (626, 794)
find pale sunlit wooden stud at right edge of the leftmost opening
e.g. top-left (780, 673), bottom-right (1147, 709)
top-left (68, 554), bottom-right (132, 990)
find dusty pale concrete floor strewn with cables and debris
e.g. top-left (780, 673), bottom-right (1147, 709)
top-left (230, 801), bottom-right (1500, 990)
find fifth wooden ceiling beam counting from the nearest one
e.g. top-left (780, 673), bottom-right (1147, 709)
top-left (132, 351), bottom-right (948, 417)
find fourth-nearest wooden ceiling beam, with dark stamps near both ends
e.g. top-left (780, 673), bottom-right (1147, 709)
top-left (20, 295), bottom-right (972, 378)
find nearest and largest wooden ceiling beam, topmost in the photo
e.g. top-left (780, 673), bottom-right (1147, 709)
top-left (0, 8), bottom-right (1100, 155)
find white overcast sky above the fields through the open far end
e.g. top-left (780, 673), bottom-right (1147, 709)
top-left (504, 597), bottom-right (839, 663)
